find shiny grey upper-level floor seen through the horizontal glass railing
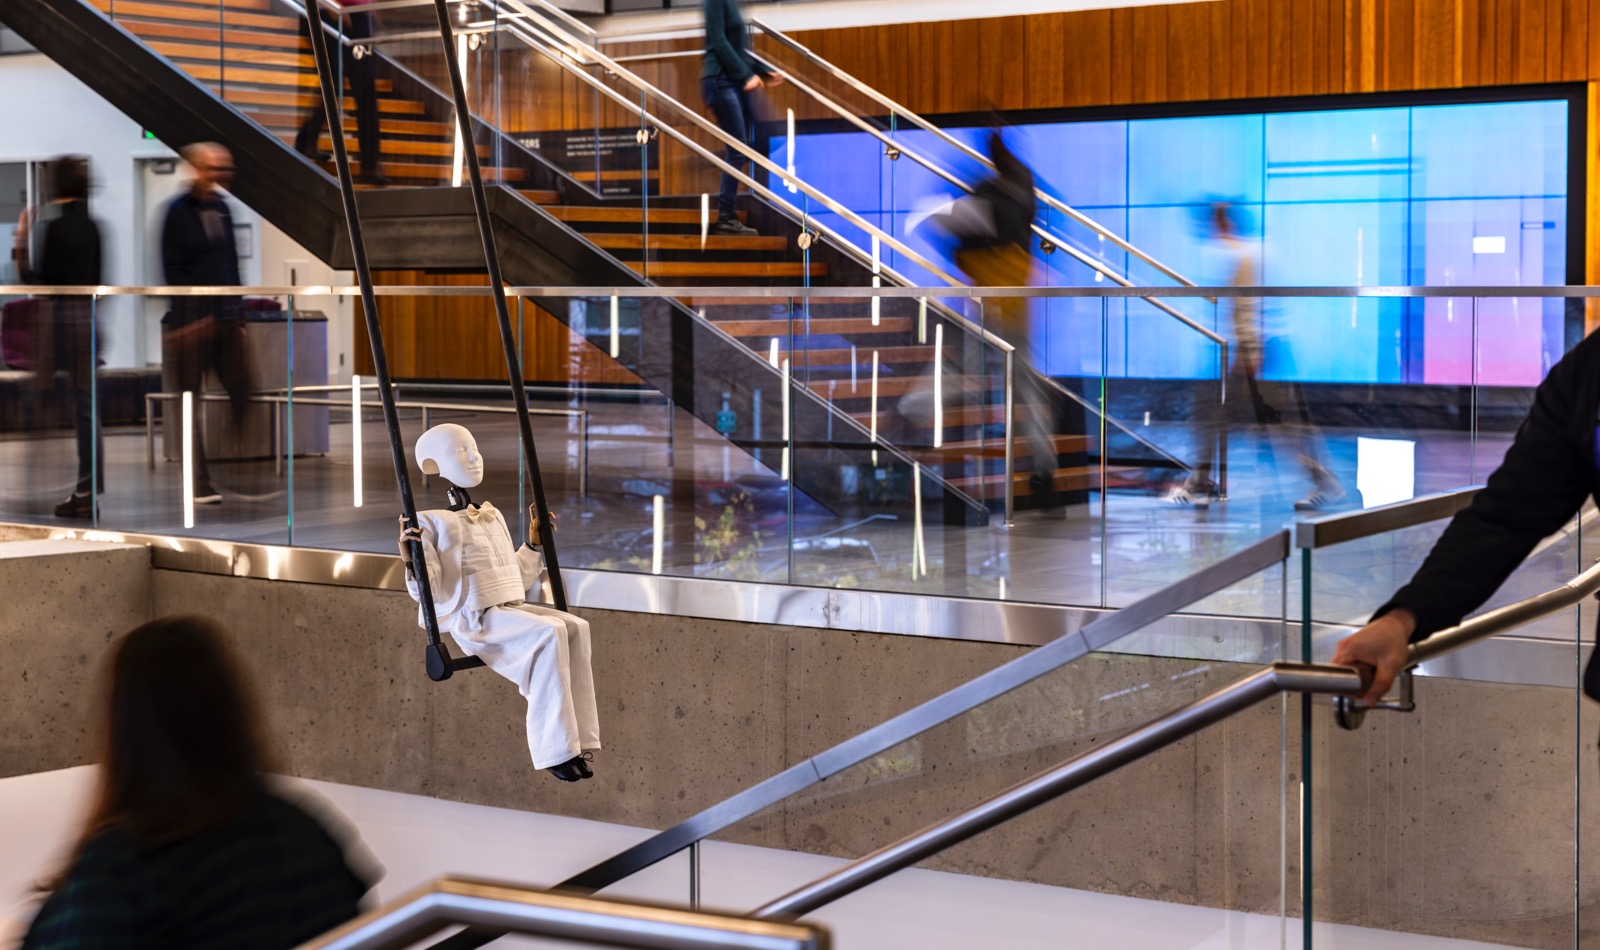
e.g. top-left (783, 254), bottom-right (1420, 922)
top-left (0, 388), bottom-right (1579, 637)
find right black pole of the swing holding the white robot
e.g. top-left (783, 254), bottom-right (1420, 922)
top-left (434, 0), bottom-right (566, 611)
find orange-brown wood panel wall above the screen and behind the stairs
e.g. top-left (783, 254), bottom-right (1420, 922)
top-left (386, 0), bottom-right (1600, 382)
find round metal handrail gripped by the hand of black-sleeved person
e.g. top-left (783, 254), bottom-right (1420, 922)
top-left (750, 550), bottom-right (1600, 920)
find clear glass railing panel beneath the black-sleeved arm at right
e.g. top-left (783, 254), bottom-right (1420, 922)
top-left (1296, 525), bottom-right (1594, 947)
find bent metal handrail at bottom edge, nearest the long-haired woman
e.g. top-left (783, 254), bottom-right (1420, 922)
top-left (299, 876), bottom-right (830, 950)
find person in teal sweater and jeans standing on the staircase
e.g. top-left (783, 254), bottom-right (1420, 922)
top-left (701, 0), bottom-right (784, 235)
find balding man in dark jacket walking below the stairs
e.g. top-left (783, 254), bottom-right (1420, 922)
top-left (162, 142), bottom-right (251, 505)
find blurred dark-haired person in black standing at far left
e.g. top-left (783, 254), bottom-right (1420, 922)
top-left (32, 155), bottom-right (106, 518)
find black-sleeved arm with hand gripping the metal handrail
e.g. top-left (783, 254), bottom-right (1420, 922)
top-left (1333, 326), bottom-right (1600, 702)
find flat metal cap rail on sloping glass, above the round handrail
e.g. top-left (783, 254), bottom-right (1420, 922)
top-left (562, 531), bottom-right (1290, 891)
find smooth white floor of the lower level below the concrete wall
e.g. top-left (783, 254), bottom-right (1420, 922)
top-left (0, 766), bottom-right (1523, 950)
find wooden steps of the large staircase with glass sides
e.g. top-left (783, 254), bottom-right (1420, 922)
top-left (90, 0), bottom-right (1099, 507)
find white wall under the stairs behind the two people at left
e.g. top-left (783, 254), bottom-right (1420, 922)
top-left (0, 54), bottom-right (354, 381)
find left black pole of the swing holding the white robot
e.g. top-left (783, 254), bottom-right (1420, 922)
top-left (306, 0), bottom-right (453, 680)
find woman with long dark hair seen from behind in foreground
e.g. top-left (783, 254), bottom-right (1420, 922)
top-left (22, 616), bottom-right (371, 950)
